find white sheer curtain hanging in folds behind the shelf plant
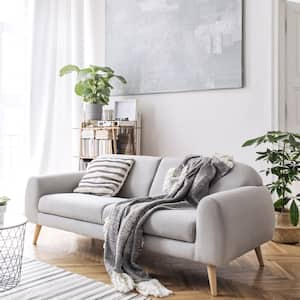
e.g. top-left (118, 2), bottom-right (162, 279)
top-left (30, 0), bottom-right (102, 173)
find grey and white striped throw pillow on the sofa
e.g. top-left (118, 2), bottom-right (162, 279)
top-left (74, 157), bottom-right (134, 196)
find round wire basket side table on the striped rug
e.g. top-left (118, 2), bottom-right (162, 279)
top-left (0, 214), bottom-right (27, 292)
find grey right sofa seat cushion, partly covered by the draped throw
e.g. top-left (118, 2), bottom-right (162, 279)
top-left (101, 205), bottom-right (196, 243)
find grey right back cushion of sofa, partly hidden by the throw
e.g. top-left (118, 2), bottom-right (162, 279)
top-left (149, 157), bottom-right (262, 196)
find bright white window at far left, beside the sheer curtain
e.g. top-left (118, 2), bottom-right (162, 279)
top-left (0, 0), bottom-right (29, 207)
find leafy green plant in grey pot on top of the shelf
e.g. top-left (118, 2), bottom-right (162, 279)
top-left (59, 65), bottom-right (127, 121)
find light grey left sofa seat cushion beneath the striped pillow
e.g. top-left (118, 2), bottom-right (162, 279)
top-left (38, 193), bottom-right (126, 224)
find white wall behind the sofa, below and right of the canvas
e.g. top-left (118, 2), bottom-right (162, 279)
top-left (92, 0), bottom-right (272, 164)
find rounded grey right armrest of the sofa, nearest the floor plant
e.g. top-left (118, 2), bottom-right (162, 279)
top-left (195, 186), bottom-right (274, 266)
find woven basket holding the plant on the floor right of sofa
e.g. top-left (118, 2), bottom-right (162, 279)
top-left (272, 212), bottom-right (300, 244)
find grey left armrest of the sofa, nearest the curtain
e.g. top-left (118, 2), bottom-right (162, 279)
top-left (25, 172), bottom-right (85, 224)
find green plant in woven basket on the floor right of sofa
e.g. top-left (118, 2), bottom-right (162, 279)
top-left (243, 131), bottom-right (300, 244)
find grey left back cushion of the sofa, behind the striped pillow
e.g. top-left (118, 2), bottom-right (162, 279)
top-left (108, 155), bottom-right (161, 198)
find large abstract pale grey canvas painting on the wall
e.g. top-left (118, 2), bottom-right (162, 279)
top-left (106, 0), bottom-right (243, 95)
